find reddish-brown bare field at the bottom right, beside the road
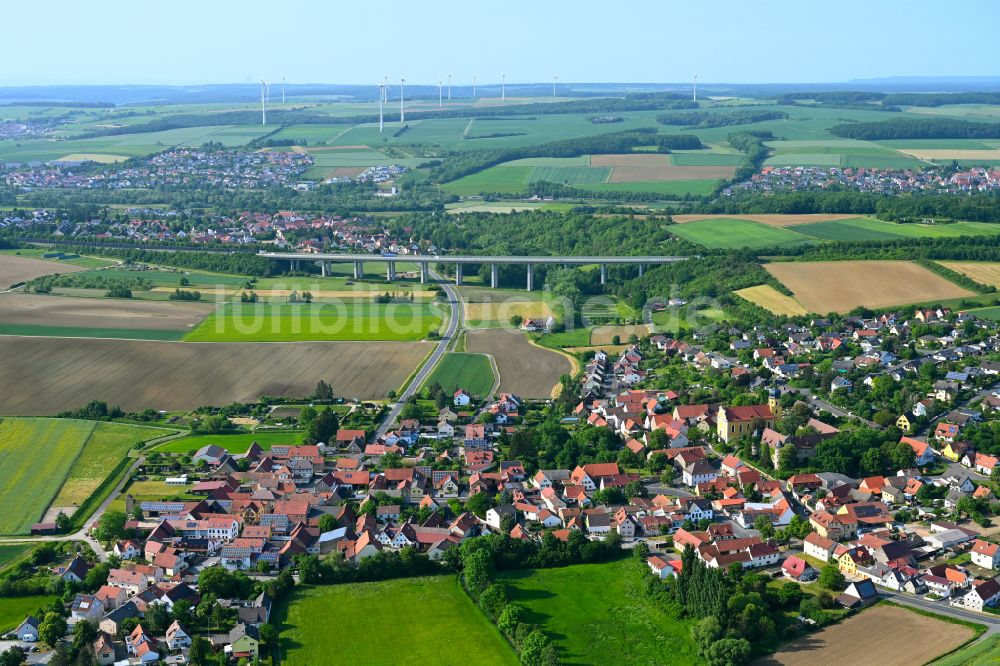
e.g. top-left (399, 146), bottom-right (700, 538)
top-left (754, 605), bottom-right (975, 666)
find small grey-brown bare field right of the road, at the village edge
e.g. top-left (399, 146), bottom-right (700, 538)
top-left (465, 328), bottom-right (575, 398)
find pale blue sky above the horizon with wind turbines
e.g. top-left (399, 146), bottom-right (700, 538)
top-left (0, 0), bottom-right (1000, 85)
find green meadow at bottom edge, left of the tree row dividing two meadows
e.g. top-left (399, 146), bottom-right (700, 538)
top-left (275, 576), bottom-right (520, 666)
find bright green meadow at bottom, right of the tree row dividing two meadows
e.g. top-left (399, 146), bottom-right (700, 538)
top-left (498, 558), bottom-right (702, 666)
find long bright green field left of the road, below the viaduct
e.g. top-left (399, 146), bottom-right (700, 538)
top-left (184, 301), bottom-right (442, 342)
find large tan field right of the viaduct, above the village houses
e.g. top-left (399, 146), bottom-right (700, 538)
top-left (764, 261), bottom-right (974, 314)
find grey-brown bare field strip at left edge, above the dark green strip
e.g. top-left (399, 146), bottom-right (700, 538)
top-left (0, 293), bottom-right (215, 331)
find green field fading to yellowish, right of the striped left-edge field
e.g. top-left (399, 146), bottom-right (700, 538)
top-left (52, 423), bottom-right (178, 506)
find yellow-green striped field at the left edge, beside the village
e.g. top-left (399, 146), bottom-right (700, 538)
top-left (0, 418), bottom-right (97, 534)
